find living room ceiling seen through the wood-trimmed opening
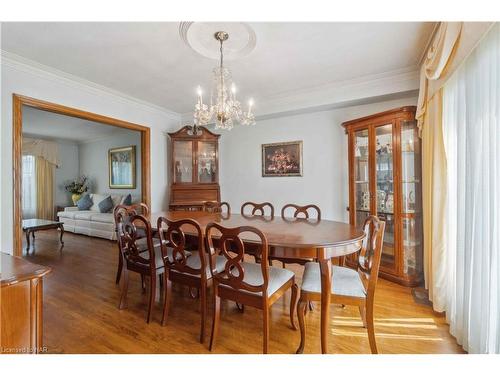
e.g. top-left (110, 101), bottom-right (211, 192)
top-left (23, 106), bottom-right (138, 143)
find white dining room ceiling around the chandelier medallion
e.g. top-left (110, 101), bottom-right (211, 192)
top-left (1, 22), bottom-right (435, 113)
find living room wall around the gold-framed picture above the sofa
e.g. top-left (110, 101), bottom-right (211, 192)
top-left (78, 129), bottom-right (142, 197)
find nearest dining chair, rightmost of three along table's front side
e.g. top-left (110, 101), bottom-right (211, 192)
top-left (205, 223), bottom-right (298, 353)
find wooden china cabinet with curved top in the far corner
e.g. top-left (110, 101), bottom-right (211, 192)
top-left (168, 126), bottom-right (220, 210)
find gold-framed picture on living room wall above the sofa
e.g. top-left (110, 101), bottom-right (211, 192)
top-left (108, 146), bottom-right (135, 189)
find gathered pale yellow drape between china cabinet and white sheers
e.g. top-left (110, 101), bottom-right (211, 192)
top-left (416, 22), bottom-right (462, 311)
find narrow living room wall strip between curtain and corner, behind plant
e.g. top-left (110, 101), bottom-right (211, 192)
top-left (54, 140), bottom-right (79, 207)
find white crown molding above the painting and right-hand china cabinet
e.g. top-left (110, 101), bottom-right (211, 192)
top-left (181, 65), bottom-right (419, 123)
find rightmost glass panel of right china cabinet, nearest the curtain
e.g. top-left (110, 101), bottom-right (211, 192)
top-left (401, 121), bottom-right (422, 274)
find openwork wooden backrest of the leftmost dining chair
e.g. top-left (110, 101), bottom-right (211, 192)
top-left (116, 211), bottom-right (156, 270)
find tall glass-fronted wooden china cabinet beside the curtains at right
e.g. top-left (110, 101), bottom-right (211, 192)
top-left (342, 107), bottom-right (423, 286)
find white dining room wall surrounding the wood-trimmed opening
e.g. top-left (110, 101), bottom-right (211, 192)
top-left (0, 58), bottom-right (180, 252)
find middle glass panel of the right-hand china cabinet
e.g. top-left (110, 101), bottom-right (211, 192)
top-left (375, 124), bottom-right (396, 268)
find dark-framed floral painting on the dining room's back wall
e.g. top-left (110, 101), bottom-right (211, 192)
top-left (262, 141), bottom-right (302, 177)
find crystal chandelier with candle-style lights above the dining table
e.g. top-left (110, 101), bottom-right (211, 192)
top-left (194, 31), bottom-right (255, 130)
